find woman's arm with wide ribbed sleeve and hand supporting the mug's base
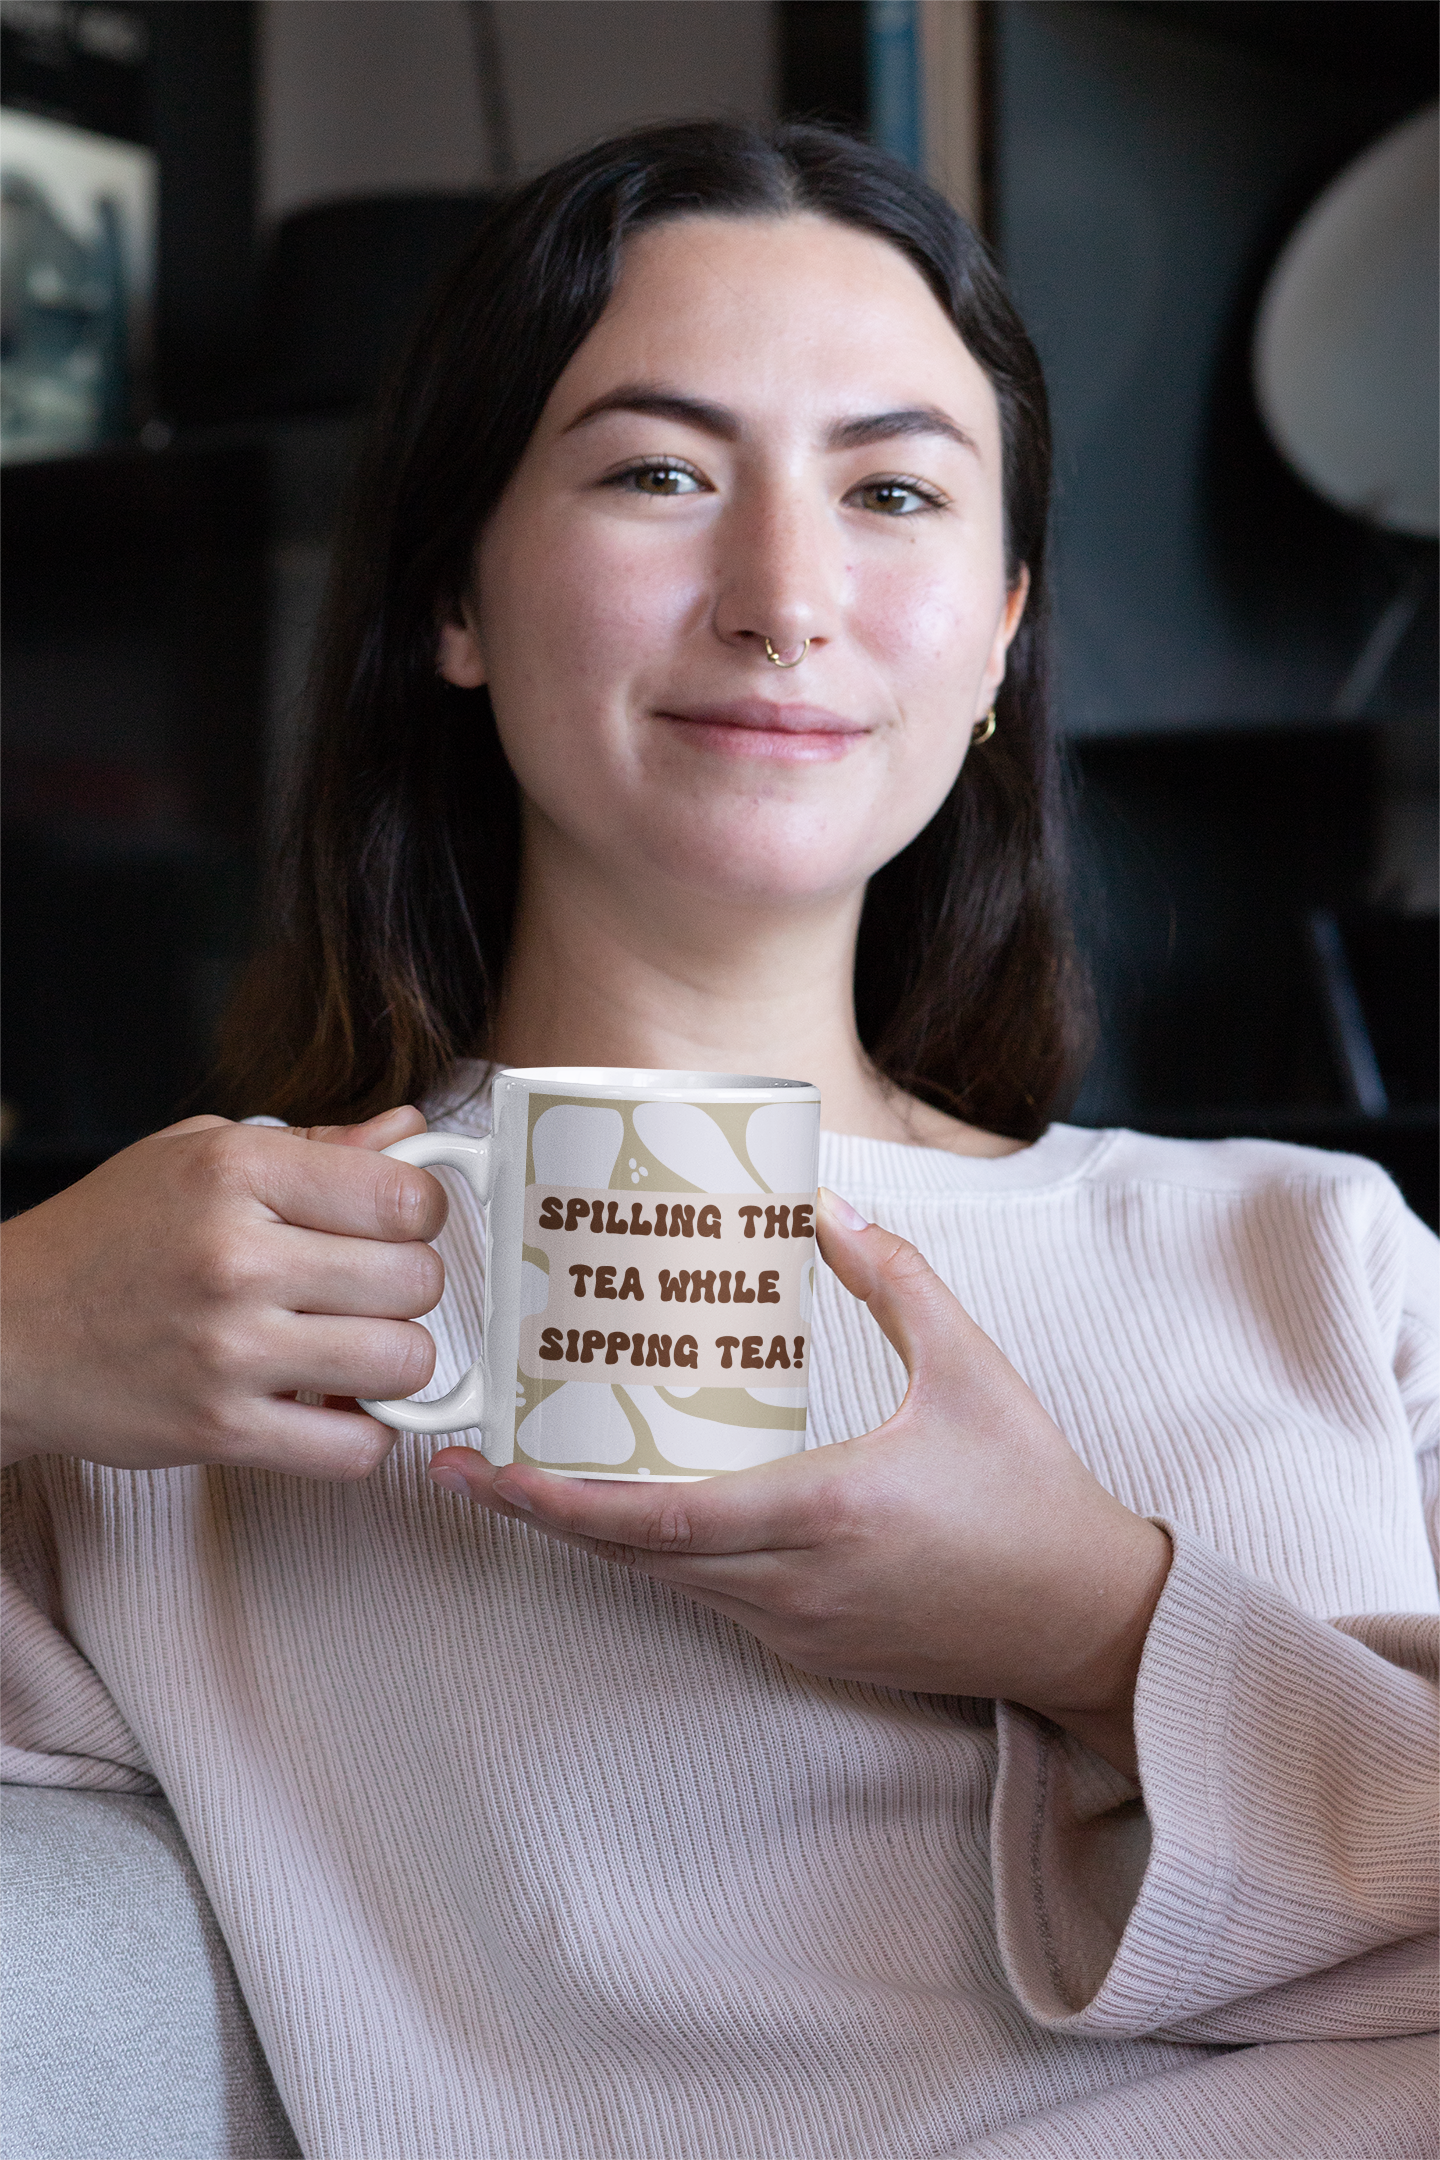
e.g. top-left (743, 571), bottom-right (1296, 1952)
top-left (432, 1183), bottom-right (1440, 2041)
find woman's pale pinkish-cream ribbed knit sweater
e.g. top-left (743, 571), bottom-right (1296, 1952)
top-left (0, 1112), bottom-right (1440, 2160)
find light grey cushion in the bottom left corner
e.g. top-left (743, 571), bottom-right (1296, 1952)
top-left (0, 1784), bottom-right (300, 2160)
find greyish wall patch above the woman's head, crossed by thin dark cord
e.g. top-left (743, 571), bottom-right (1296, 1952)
top-left (259, 0), bottom-right (775, 218)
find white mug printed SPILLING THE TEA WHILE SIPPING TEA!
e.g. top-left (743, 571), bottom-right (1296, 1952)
top-left (363, 1065), bottom-right (820, 1480)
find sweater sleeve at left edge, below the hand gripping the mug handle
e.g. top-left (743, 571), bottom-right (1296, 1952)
top-left (0, 1462), bottom-right (158, 1793)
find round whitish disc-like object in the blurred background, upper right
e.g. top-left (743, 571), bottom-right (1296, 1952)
top-left (1254, 104), bottom-right (1440, 540)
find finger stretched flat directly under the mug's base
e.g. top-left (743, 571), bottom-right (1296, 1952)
top-left (430, 1447), bottom-right (833, 1555)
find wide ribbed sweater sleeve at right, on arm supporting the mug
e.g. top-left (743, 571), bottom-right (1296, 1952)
top-left (993, 1525), bottom-right (1440, 2041)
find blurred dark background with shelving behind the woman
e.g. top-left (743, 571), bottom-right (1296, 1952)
top-left (0, 0), bottom-right (1440, 1223)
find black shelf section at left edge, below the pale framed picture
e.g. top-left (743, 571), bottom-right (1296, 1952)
top-left (0, 436), bottom-right (268, 1207)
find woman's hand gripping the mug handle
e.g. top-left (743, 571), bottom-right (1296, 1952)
top-left (0, 1108), bottom-right (445, 1477)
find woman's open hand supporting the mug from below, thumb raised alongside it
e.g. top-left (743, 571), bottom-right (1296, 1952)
top-left (430, 1194), bottom-right (1170, 1776)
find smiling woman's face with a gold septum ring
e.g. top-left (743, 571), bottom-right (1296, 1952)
top-left (440, 216), bottom-right (1023, 907)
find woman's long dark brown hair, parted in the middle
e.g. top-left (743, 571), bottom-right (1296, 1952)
top-left (218, 121), bottom-right (1084, 1138)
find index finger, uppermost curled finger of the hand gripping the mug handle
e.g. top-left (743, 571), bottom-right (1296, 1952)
top-left (181, 1125), bottom-right (447, 1244)
